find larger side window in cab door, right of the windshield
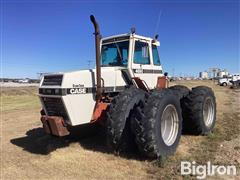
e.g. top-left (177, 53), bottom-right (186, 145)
top-left (133, 41), bottom-right (150, 64)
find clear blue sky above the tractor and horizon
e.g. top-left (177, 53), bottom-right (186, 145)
top-left (1, 0), bottom-right (240, 78)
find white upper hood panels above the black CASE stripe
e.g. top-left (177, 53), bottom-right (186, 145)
top-left (40, 67), bottom-right (127, 88)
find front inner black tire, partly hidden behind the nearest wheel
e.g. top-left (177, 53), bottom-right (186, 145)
top-left (106, 87), bottom-right (145, 153)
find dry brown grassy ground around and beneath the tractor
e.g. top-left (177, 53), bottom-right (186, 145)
top-left (0, 81), bottom-right (240, 179)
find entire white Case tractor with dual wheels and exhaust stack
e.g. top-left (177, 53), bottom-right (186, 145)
top-left (39, 15), bottom-right (216, 158)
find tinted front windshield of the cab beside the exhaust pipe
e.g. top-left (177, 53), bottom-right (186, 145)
top-left (101, 41), bottom-right (129, 66)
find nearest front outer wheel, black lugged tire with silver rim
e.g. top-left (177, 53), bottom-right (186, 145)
top-left (131, 89), bottom-right (182, 158)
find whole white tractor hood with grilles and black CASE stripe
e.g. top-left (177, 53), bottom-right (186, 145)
top-left (39, 67), bottom-right (127, 126)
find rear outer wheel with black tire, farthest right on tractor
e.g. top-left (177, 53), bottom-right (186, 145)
top-left (182, 86), bottom-right (216, 135)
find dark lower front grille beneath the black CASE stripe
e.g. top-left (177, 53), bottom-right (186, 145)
top-left (42, 97), bottom-right (69, 120)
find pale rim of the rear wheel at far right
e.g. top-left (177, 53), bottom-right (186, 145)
top-left (203, 97), bottom-right (215, 127)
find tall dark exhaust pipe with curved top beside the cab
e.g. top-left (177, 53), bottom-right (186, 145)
top-left (90, 15), bottom-right (102, 101)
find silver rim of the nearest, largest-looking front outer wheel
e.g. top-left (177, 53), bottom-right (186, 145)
top-left (161, 104), bottom-right (179, 146)
